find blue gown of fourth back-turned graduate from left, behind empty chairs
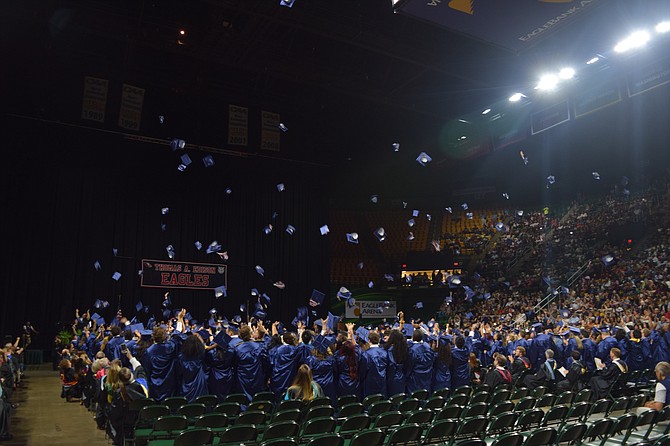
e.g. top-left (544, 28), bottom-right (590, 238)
top-left (233, 341), bottom-right (268, 401)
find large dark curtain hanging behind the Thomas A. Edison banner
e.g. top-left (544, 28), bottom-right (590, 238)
top-left (0, 117), bottom-right (329, 348)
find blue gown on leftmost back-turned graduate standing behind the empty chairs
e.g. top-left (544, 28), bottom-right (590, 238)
top-left (142, 335), bottom-right (181, 401)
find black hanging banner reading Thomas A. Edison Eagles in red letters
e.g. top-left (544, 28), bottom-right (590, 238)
top-left (141, 259), bottom-right (228, 290)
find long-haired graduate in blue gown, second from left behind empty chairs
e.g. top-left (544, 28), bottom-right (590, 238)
top-left (177, 332), bottom-right (209, 403)
